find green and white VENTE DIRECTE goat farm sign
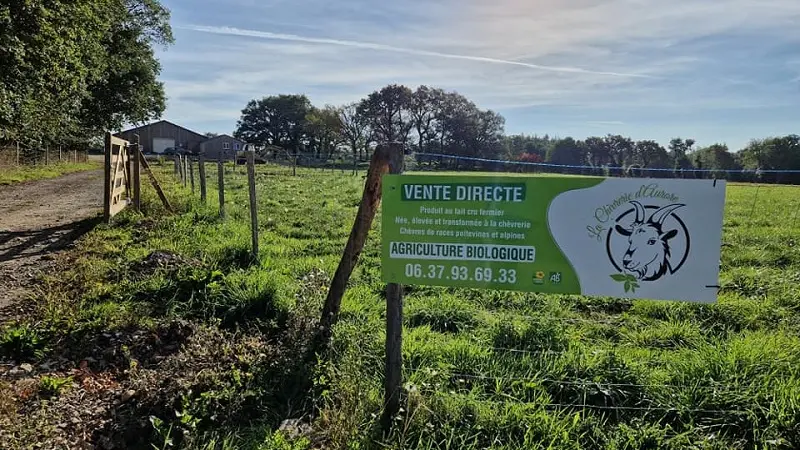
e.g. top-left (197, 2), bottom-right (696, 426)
top-left (381, 175), bottom-right (725, 302)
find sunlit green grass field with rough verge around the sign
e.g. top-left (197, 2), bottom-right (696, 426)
top-left (0, 166), bottom-right (800, 449)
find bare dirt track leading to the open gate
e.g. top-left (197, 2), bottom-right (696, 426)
top-left (0, 170), bottom-right (103, 316)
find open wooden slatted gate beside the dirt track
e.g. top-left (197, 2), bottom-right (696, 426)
top-left (103, 133), bottom-right (131, 222)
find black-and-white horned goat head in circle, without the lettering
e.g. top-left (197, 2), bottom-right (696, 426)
top-left (606, 201), bottom-right (690, 284)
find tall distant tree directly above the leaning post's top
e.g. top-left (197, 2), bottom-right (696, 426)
top-left (358, 84), bottom-right (413, 146)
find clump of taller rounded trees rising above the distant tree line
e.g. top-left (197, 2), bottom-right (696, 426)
top-left (234, 84), bottom-right (505, 163)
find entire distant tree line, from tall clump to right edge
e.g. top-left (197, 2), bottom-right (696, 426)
top-left (234, 84), bottom-right (800, 183)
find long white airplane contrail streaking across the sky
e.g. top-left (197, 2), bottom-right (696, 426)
top-left (180, 25), bottom-right (654, 78)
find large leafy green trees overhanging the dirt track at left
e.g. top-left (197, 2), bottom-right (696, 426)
top-left (0, 0), bottom-right (173, 158)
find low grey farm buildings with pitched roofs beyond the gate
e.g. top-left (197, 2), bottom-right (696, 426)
top-left (117, 120), bottom-right (245, 160)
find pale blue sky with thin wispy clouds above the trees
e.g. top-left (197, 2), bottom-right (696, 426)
top-left (158, 0), bottom-right (800, 150)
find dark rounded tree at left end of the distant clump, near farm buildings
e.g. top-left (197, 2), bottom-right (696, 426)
top-left (233, 94), bottom-right (312, 154)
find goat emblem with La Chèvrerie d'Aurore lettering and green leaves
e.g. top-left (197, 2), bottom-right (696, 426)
top-left (587, 184), bottom-right (691, 293)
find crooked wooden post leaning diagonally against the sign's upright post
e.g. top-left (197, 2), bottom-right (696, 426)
top-left (317, 144), bottom-right (402, 348)
